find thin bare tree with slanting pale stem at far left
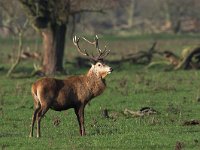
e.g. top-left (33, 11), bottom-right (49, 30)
top-left (0, 0), bottom-right (33, 77)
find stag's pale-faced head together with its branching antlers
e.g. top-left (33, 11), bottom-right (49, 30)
top-left (73, 35), bottom-right (113, 78)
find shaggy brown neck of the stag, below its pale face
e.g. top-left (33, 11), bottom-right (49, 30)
top-left (86, 69), bottom-right (106, 97)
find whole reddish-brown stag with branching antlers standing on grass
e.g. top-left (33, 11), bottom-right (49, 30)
top-left (30, 36), bottom-right (113, 137)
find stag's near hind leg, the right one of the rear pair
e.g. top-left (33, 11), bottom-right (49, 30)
top-left (37, 103), bottom-right (49, 138)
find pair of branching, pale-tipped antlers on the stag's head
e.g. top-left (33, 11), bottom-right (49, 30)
top-left (73, 35), bottom-right (110, 62)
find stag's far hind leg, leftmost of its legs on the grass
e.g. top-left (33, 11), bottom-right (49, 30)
top-left (29, 98), bottom-right (41, 137)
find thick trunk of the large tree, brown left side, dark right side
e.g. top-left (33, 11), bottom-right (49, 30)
top-left (42, 24), bottom-right (67, 75)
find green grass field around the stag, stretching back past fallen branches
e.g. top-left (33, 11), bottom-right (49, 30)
top-left (0, 36), bottom-right (200, 150)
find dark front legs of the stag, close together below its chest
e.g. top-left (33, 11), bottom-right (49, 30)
top-left (74, 106), bottom-right (85, 136)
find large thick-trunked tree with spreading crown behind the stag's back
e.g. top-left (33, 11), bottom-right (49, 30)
top-left (19, 0), bottom-right (116, 74)
